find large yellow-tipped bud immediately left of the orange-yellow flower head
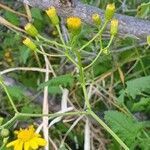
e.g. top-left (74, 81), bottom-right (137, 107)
top-left (46, 6), bottom-right (59, 26)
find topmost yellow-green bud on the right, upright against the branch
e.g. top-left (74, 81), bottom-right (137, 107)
top-left (105, 3), bottom-right (115, 21)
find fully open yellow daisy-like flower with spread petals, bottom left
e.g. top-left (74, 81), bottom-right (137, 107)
top-left (6, 126), bottom-right (46, 150)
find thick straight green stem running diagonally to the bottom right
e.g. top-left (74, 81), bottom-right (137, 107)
top-left (89, 111), bottom-right (129, 150)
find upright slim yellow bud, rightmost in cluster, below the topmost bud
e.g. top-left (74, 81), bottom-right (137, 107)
top-left (110, 19), bottom-right (119, 36)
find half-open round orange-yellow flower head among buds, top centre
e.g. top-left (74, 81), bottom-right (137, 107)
top-left (67, 17), bottom-right (82, 33)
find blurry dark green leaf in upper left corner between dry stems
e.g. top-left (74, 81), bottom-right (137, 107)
top-left (4, 11), bottom-right (20, 26)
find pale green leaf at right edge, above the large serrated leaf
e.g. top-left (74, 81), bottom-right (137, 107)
top-left (126, 76), bottom-right (150, 98)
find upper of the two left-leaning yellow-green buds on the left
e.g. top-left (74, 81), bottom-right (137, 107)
top-left (24, 23), bottom-right (38, 37)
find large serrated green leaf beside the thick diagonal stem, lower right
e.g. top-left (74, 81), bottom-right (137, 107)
top-left (105, 111), bottom-right (143, 146)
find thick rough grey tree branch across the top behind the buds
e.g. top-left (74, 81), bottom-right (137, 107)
top-left (19, 0), bottom-right (150, 40)
